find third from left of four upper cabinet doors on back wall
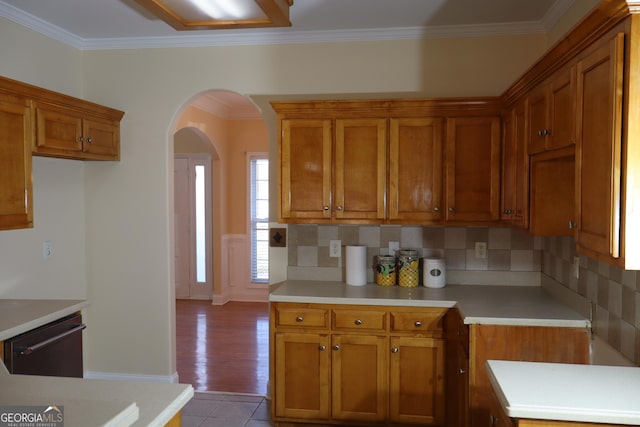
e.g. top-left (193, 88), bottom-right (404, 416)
top-left (389, 118), bottom-right (443, 223)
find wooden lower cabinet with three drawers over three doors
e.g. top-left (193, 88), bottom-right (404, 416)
top-left (270, 303), bottom-right (447, 426)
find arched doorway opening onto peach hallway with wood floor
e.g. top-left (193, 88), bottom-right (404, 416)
top-left (174, 91), bottom-right (268, 394)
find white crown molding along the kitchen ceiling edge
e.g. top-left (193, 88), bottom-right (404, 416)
top-left (0, 0), bottom-right (574, 50)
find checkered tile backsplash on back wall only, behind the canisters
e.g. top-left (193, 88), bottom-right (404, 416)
top-left (287, 224), bottom-right (542, 282)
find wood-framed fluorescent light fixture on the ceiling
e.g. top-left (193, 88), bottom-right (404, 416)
top-left (136, 0), bottom-right (293, 31)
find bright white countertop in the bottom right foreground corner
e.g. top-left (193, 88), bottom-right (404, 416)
top-left (487, 360), bottom-right (640, 425)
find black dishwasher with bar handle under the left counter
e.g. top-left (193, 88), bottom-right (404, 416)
top-left (4, 313), bottom-right (85, 378)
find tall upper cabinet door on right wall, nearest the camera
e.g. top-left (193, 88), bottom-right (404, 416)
top-left (575, 34), bottom-right (624, 258)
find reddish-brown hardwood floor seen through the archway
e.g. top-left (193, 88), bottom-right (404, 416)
top-left (176, 300), bottom-right (269, 396)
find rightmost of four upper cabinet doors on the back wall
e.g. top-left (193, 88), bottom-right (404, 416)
top-left (446, 117), bottom-right (500, 223)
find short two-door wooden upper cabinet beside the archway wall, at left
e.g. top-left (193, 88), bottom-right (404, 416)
top-left (33, 103), bottom-right (120, 160)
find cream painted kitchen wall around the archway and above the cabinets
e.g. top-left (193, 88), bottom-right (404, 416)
top-left (0, 4), bottom-right (592, 379)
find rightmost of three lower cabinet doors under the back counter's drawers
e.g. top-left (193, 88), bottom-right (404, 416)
top-left (389, 336), bottom-right (445, 425)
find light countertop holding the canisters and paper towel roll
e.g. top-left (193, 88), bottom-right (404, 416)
top-left (269, 280), bottom-right (591, 327)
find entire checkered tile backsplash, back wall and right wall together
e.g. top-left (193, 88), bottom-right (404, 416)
top-left (287, 225), bottom-right (640, 365)
